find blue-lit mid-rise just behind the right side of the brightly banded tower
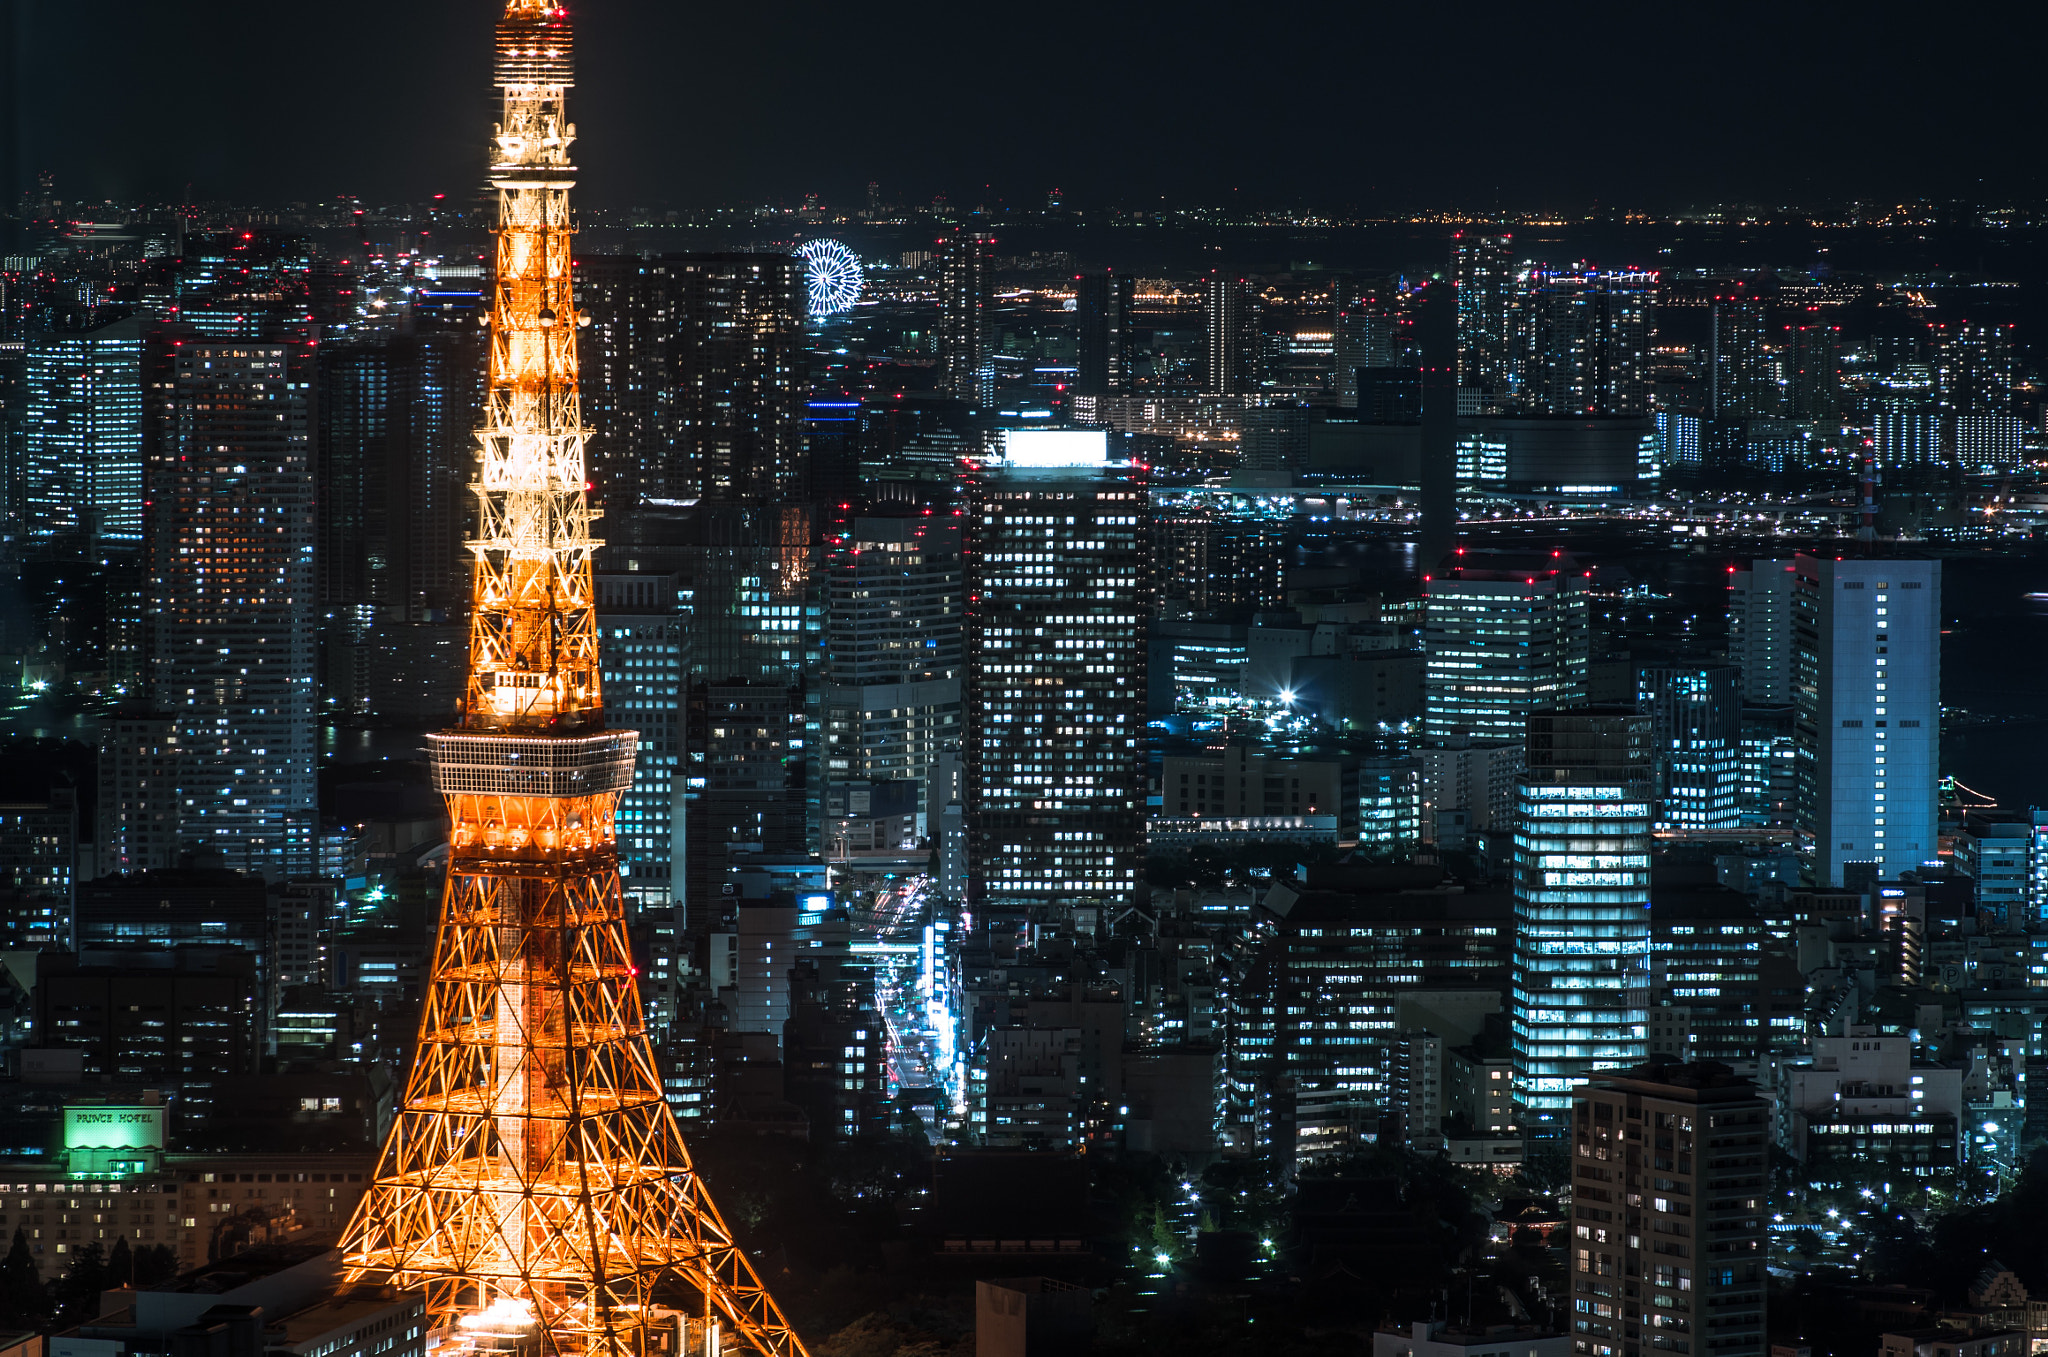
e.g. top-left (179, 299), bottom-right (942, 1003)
top-left (1636, 663), bottom-right (1743, 831)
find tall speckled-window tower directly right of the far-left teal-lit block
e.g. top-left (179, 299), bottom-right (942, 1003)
top-left (147, 340), bottom-right (317, 878)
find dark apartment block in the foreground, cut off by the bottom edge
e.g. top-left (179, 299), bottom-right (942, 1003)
top-left (1569, 1060), bottom-right (1774, 1357)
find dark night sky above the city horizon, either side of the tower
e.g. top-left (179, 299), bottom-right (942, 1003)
top-left (16, 0), bottom-right (2048, 211)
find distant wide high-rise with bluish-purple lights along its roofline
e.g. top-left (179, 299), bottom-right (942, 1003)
top-left (1516, 270), bottom-right (1657, 415)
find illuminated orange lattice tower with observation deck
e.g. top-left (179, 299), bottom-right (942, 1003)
top-left (344, 0), bottom-right (803, 1357)
